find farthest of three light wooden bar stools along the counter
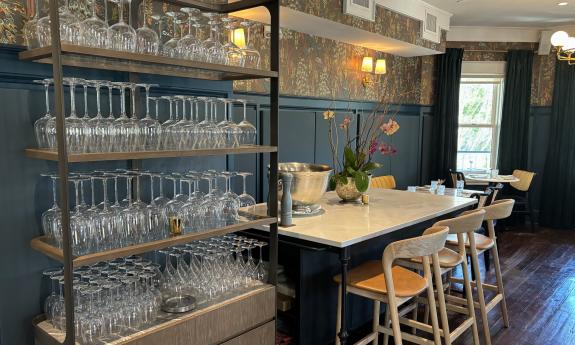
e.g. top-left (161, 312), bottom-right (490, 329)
top-left (447, 199), bottom-right (515, 345)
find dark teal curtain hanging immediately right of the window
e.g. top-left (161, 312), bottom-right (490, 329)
top-left (497, 50), bottom-right (533, 174)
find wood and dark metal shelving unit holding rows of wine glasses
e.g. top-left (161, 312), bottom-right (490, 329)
top-left (19, 0), bottom-right (279, 345)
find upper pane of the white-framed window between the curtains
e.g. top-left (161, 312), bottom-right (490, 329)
top-left (459, 84), bottom-right (496, 124)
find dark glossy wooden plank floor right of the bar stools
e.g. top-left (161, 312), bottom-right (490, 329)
top-left (454, 229), bottom-right (575, 345)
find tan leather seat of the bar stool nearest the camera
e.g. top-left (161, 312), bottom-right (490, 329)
top-left (334, 260), bottom-right (427, 297)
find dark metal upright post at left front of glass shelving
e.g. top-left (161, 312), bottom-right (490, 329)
top-left (50, 0), bottom-right (75, 345)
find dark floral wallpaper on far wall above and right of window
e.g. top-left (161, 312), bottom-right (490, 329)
top-left (447, 42), bottom-right (556, 106)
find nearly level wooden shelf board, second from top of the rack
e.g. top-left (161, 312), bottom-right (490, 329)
top-left (25, 145), bottom-right (277, 163)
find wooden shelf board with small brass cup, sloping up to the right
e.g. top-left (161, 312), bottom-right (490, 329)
top-left (30, 216), bottom-right (277, 267)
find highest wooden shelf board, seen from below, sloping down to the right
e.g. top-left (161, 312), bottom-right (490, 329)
top-left (19, 44), bottom-right (278, 80)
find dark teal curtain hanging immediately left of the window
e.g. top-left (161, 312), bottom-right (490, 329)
top-left (430, 48), bottom-right (463, 179)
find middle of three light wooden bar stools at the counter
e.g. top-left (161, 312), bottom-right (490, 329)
top-left (400, 209), bottom-right (485, 345)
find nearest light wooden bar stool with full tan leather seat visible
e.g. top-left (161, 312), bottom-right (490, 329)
top-left (334, 227), bottom-right (448, 345)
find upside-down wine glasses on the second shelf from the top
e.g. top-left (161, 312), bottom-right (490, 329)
top-left (34, 78), bottom-right (257, 153)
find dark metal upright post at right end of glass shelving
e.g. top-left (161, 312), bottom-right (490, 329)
top-left (267, 0), bottom-right (280, 285)
